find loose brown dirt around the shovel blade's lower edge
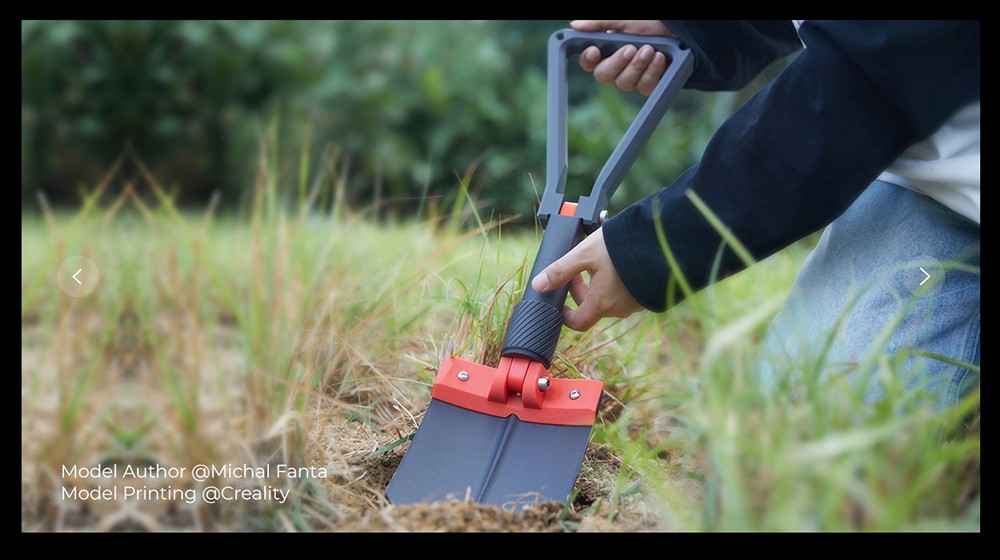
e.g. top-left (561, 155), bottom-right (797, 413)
top-left (306, 396), bottom-right (664, 532)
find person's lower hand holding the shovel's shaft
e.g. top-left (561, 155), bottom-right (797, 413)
top-left (531, 228), bottom-right (642, 331)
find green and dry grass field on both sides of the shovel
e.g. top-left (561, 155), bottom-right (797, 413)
top-left (21, 147), bottom-right (980, 531)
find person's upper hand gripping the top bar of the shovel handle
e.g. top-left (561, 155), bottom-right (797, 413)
top-left (570, 19), bottom-right (676, 96)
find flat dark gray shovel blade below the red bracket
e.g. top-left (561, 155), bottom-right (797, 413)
top-left (386, 399), bottom-right (592, 511)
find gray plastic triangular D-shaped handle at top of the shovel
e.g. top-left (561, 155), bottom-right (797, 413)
top-left (538, 29), bottom-right (694, 233)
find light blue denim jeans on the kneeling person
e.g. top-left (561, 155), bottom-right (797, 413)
top-left (758, 181), bottom-right (980, 410)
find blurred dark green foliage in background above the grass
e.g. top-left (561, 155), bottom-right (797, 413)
top-left (21, 20), bottom-right (731, 221)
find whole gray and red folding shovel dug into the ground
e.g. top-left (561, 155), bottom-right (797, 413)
top-left (386, 29), bottom-right (694, 510)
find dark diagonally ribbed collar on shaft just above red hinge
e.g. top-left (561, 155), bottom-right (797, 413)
top-left (500, 300), bottom-right (563, 368)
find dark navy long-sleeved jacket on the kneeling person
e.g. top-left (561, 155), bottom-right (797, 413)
top-left (603, 21), bottom-right (980, 311)
